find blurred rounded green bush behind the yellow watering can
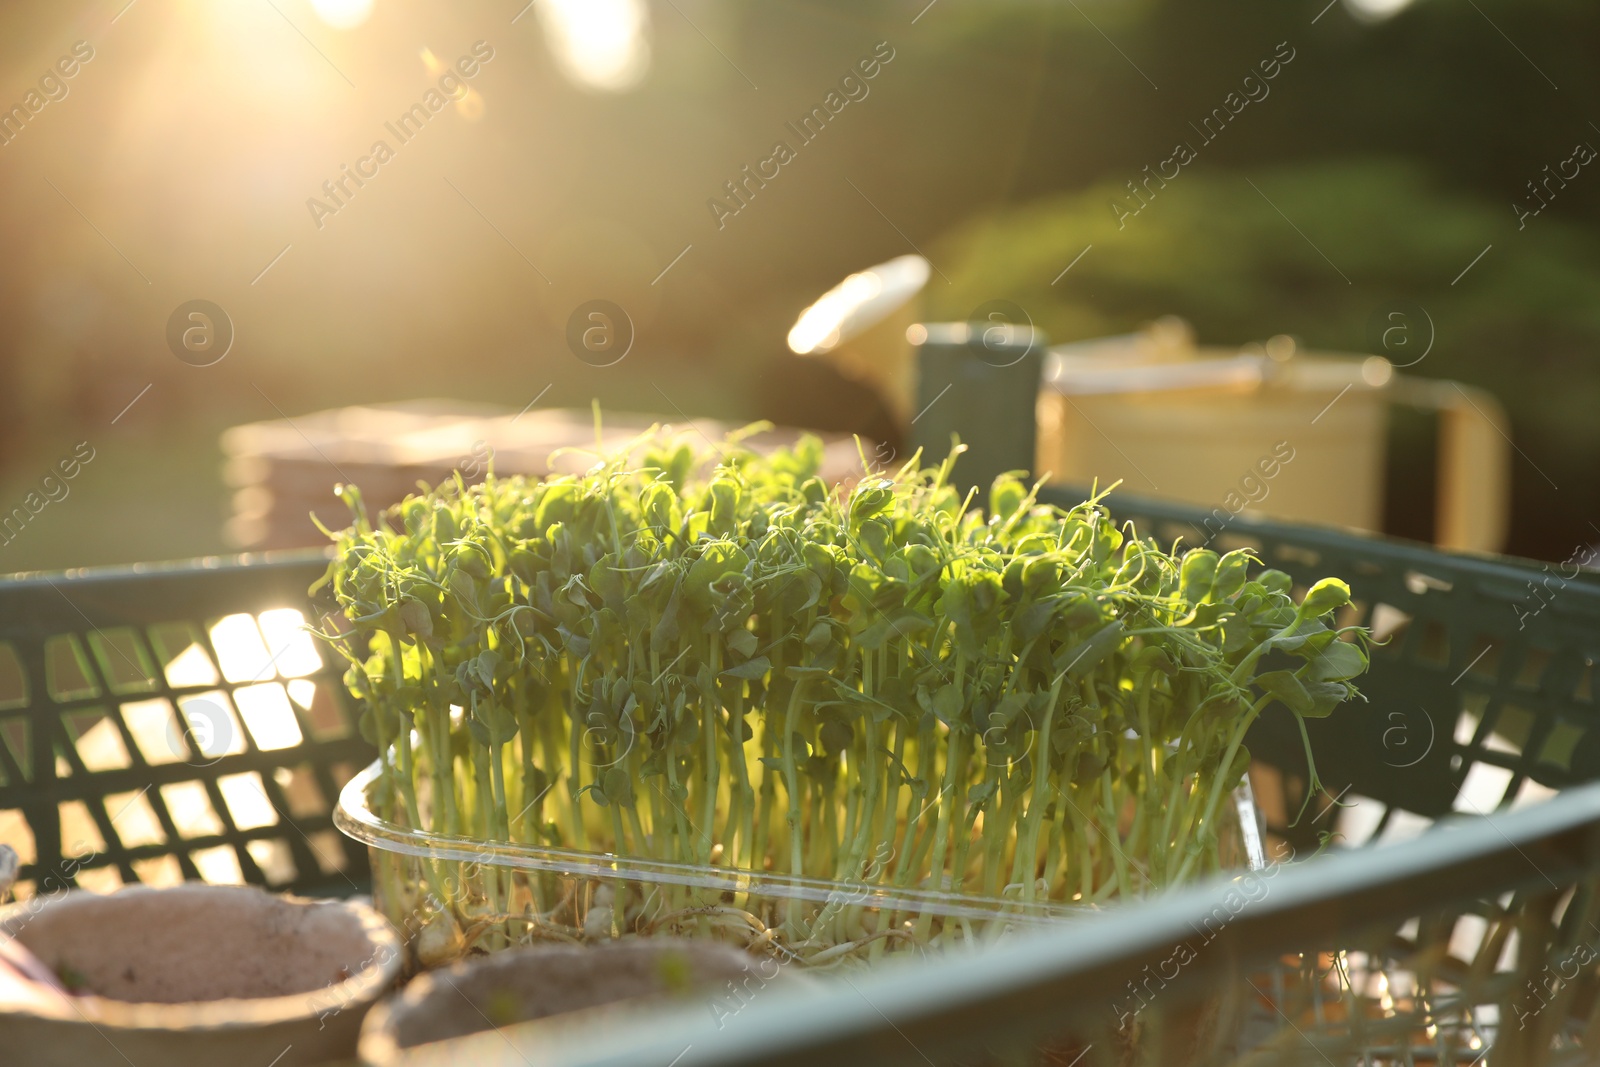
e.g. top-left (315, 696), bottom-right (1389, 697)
top-left (930, 160), bottom-right (1600, 415)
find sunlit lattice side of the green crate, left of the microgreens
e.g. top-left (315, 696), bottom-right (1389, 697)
top-left (0, 552), bottom-right (374, 897)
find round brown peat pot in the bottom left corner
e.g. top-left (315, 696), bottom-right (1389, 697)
top-left (0, 883), bottom-right (400, 1067)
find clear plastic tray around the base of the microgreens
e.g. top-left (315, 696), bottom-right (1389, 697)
top-left (334, 763), bottom-right (1266, 968)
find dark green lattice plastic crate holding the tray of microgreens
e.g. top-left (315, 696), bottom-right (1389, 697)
top-left (0, 490), bottom-right (1600, 1067)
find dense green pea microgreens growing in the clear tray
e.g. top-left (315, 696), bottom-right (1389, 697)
top-left (325, 435), bottom-right (1366, 958)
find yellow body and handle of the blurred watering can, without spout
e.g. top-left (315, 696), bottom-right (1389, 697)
top-left (1037, 320), bottom-right (1509, 552)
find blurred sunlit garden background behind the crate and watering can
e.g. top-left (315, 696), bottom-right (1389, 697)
top-left (0, 0), bottom-right (1600, 571)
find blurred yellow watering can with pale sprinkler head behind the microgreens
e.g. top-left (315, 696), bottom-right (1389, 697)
top-left (789, 256), bottom-right (1510, 552)
